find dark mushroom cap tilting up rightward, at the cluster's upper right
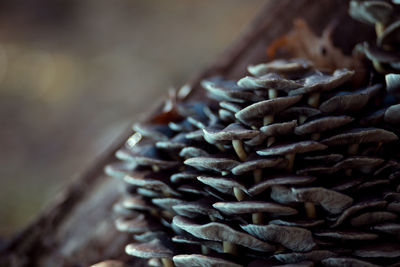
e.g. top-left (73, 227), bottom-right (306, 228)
top-left (319, 84), bottom-right (382, 114)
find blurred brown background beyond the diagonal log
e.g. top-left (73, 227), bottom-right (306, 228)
top-left (0, 0), bottom-right (265, 239)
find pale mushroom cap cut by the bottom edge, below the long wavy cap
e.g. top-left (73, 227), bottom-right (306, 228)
top-left (172, 254), bottom-right (243, 267)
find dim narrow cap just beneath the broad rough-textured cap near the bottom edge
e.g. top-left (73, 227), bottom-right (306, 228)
top-left (273, 250), bottom-right (336, 263)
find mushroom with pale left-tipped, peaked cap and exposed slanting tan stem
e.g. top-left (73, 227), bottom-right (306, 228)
top-left (203, 123), bottom-right (259, 161)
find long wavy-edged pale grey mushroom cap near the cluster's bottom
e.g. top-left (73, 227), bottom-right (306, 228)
top-left (173, 216), bottom-right (275, 252)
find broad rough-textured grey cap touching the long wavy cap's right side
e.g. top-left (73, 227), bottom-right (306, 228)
top-left (240, 224), bottom-right (316, 252)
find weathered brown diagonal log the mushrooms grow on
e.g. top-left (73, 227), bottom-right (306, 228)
top-left (0, 0), bottom-right (372, 266)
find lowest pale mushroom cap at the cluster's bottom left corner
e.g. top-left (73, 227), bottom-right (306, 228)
top-left (125, 239), bottom-right (174, 259)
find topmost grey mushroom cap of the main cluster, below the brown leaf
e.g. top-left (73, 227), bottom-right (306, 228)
top-left (247, 58), bottom-right (312, 76)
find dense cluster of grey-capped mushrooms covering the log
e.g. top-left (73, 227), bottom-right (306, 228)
top-left (101, 1), bottom-right (400, 267)
